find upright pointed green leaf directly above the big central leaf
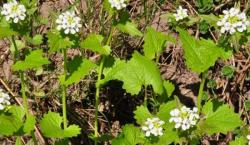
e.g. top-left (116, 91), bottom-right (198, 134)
top-left (143, 27), bottom-right (176, 59)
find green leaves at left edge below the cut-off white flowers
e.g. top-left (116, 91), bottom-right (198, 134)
top-left (0, 106), bottom-right (36, 136)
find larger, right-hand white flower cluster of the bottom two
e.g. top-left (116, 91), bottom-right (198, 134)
top-left (169, 106), bottom-right (199, 130)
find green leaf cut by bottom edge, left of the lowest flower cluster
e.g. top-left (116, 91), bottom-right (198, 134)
top-left (112, 124), bottom-right (144, 145)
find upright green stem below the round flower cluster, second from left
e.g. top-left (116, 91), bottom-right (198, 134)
top-left (62, 49), bottom-right (67, 129)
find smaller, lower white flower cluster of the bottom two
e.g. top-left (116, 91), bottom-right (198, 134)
top-left (142, 117), bottom-right (165, 137)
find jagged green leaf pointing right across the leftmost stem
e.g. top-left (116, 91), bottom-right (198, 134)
top-left (13, 50), bottom-right (50, 71)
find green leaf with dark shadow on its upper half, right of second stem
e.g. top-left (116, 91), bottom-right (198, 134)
top-left (62, 56), bottom-right (96, 85)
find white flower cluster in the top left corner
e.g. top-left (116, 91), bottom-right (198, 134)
top-left (1, 0), bottom-right (26, 23)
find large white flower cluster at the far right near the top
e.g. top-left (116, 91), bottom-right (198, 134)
top-left (217, 8), bottom-right (249, 34)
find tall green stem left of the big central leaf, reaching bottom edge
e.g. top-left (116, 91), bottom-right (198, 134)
top-left (94, 26), bottom-right (114, 145)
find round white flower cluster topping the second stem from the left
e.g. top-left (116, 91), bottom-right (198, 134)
top-left (56, 11), bottom-right (82, 34)
